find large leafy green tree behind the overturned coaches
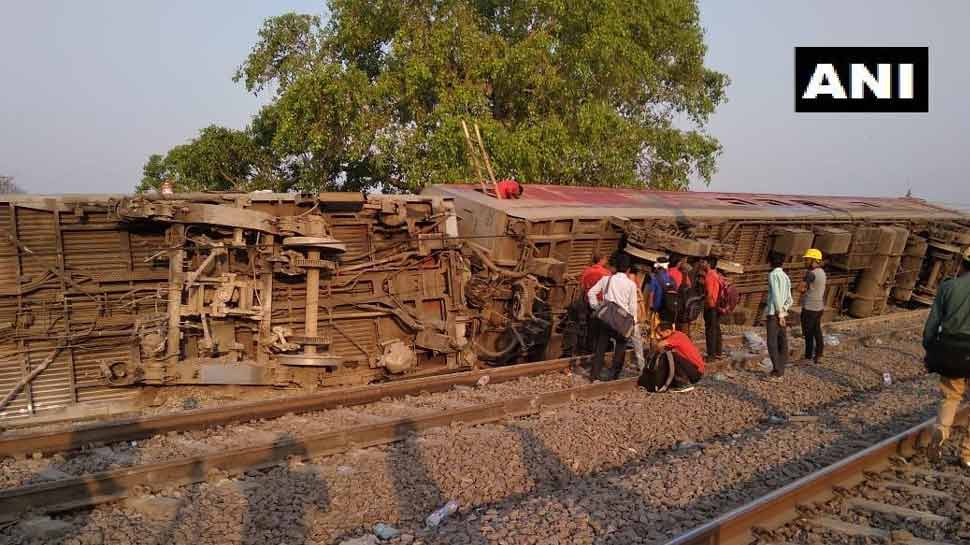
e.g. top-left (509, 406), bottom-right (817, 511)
top-left (143, 0), bottom-right (728, 191)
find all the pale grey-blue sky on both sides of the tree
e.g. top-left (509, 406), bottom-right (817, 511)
top-left (0, 0), bottom-right (970, 208)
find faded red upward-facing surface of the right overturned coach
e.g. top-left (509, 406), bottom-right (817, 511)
top-left (425, 184), bottom-right (968, 220)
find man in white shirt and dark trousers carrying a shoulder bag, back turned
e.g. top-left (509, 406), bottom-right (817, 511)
top-left (586, 256), bottom-right (641, 380)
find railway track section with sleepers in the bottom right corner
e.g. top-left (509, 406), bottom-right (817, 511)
top-left (667, 407), bottom-right (970, 545)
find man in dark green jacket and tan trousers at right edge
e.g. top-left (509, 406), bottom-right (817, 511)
top-left (923, 249), bottom-right (970, 469)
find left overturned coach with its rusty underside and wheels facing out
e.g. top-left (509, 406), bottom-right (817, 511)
top-left (0, 193), bottom-right (472, 417)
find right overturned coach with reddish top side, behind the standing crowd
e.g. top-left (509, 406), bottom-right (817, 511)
top-left (426, 185), bottom-right (970, 361)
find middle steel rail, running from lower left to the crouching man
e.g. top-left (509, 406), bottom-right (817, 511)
top-left (0, 378), bottom-right (636, 522)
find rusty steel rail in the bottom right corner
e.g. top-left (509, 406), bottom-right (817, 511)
top-left (666, 407), bottom-right (968, 545)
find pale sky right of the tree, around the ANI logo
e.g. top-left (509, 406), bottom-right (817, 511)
top-left (700, 0), bottom-right (970, 208)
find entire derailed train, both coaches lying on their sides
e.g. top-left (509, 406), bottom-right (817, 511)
top-left (0, 185), bottom-right (970, 419)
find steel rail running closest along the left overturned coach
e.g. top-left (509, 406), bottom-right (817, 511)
top-left (0, 356), bottom-right (587, 458)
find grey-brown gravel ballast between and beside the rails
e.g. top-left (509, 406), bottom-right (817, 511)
top-left (0, 326), bottom-right (952, 545)
